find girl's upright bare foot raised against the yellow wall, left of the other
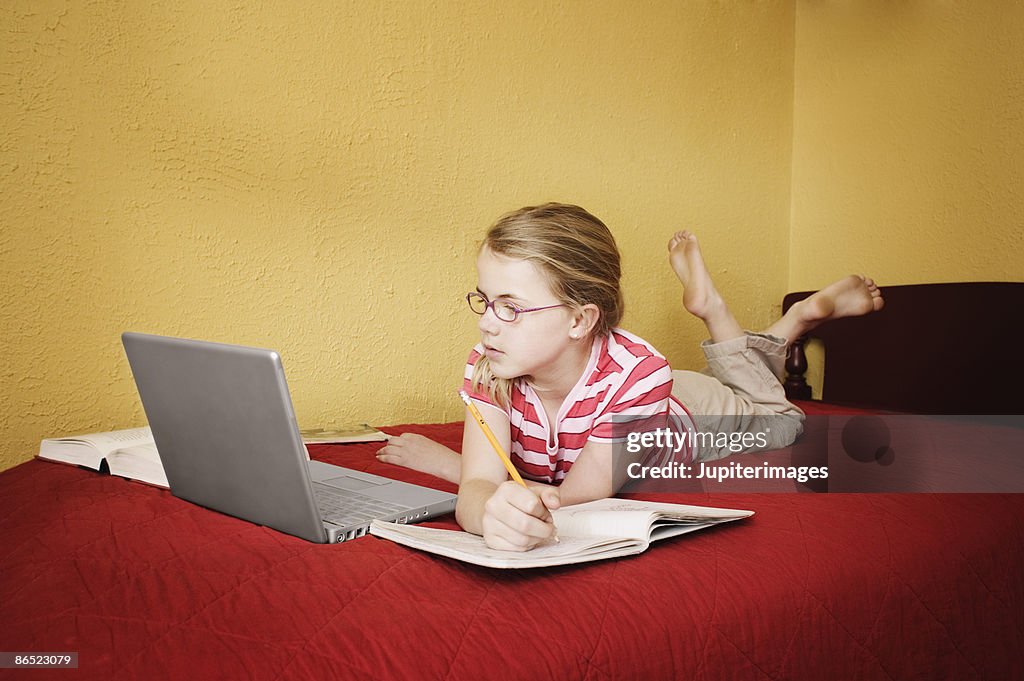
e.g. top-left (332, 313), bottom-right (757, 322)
top-left (669, 229), bottom-right (743, 343)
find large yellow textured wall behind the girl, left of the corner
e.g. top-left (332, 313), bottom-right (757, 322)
top-left (0, 0), bottom-right (795, 467)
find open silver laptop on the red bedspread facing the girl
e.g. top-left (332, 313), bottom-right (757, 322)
top-left (121, 333), bottom-right (456, 543)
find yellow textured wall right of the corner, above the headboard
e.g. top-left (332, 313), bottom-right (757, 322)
top-left (790, 0), bottom-right (1024, 394)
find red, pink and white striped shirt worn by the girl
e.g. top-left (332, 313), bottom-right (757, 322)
top-left (463, 329), bottom-right (692, 484)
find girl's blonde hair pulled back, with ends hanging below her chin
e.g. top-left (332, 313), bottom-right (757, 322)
top-left (471, 204), bottom-right (625, 407)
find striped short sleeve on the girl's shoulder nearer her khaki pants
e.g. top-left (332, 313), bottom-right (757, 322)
top-left (590, 355), bottom-right (673, 442)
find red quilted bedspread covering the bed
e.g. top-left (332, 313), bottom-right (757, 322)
top-left (0, 285), bottom-right (1024, 680)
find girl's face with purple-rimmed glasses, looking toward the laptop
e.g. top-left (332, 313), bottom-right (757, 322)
top-left (476, 247), bottom-right (577, 382)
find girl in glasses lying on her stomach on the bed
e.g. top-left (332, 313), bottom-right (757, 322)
top-left (378, 204), bottom-right (883, 551)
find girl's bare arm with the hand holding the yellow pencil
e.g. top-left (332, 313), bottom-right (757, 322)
top-left (455, 407), bottom-right (558, 551)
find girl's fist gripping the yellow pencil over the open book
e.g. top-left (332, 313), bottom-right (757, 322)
top-left (482, 480), bottom-right (559, 551)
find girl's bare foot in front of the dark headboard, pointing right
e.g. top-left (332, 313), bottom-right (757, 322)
top-left (767, 274), bottom-right (886, 342)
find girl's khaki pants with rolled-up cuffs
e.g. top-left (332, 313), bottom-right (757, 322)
top-left (672, 332), bottom-right (804, 461)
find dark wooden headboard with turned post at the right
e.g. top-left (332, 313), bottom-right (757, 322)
top-left (782, 283), bottom-right (1024, 414)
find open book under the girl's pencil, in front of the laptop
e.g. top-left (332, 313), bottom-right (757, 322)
top-left (370, 499), bottom-right (754, 567)
